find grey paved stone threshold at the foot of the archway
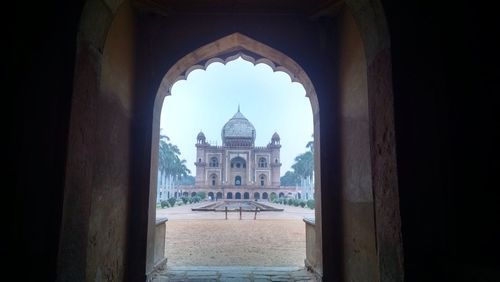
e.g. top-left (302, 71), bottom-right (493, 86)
top-left (153, 266), bottom-right (316, 282)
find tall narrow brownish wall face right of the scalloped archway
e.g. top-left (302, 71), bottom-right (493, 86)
top-left (338, 8), bottom-right (379, 281)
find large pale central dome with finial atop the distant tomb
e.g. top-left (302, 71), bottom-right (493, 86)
top-left (221, 107), bottom-right (255, 146)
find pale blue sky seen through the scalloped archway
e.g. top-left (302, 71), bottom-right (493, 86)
top-left (160, 57), bottom-right (313, 176)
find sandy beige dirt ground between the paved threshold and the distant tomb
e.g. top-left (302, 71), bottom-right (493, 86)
top-left (157, 200), bottom-right (314, 266)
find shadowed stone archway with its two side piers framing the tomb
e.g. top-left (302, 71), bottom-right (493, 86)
top-left (58, 0), bottom-right (403, 281)
